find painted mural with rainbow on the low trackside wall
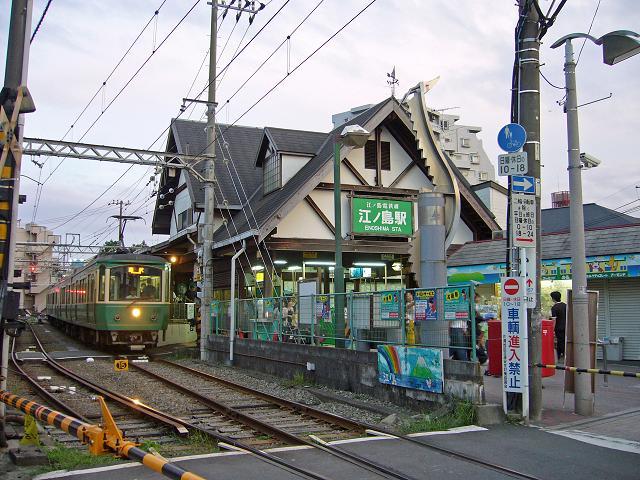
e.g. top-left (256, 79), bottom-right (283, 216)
top-left (378, 345), bottom-right (444, 393)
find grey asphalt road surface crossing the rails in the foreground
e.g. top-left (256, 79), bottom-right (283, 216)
top-left (36, 425), bottom-right (640, 480)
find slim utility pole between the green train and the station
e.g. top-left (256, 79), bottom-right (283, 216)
top-left (200, 0), bottom-right (218, 360)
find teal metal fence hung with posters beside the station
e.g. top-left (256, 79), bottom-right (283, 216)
top-left (211, 285), bottom-right (482, 360)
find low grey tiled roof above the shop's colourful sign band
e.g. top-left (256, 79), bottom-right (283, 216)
top-left (447, 225), bottom-right (640, 267)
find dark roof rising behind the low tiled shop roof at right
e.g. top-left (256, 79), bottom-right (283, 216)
top-left (541, 203), bottom-right (640, 234)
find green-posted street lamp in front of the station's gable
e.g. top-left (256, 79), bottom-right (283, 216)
top-left (333, 125), bottom-right (370, 348)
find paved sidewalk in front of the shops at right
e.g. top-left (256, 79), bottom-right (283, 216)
top-left (484, 361), bottom-right (640, 446)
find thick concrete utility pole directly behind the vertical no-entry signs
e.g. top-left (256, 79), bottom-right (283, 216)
top-left (517, 0), bottom-right (542, 420)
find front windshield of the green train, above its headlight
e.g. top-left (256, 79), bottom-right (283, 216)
top-left (109, 265), bottom-right (162, 302)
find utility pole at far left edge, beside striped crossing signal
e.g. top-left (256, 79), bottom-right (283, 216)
top-left (0, 0), bottom-right (35, 447)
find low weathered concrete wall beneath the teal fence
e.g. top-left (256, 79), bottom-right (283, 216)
top-left (207, 335), bottom-right (484, 409)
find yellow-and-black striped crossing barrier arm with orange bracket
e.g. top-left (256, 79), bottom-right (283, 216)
top-left (0, 390), bottom-right (204, 480)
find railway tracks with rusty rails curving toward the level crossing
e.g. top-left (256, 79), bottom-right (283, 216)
top-left (8, 320), bottom-right (537, 480)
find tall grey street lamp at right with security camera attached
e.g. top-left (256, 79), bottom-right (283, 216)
top-left (551, 30), bottom-right (640, 415)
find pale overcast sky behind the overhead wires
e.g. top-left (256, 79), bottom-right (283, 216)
top-left (0, 0), bottom-right (640, 251)
